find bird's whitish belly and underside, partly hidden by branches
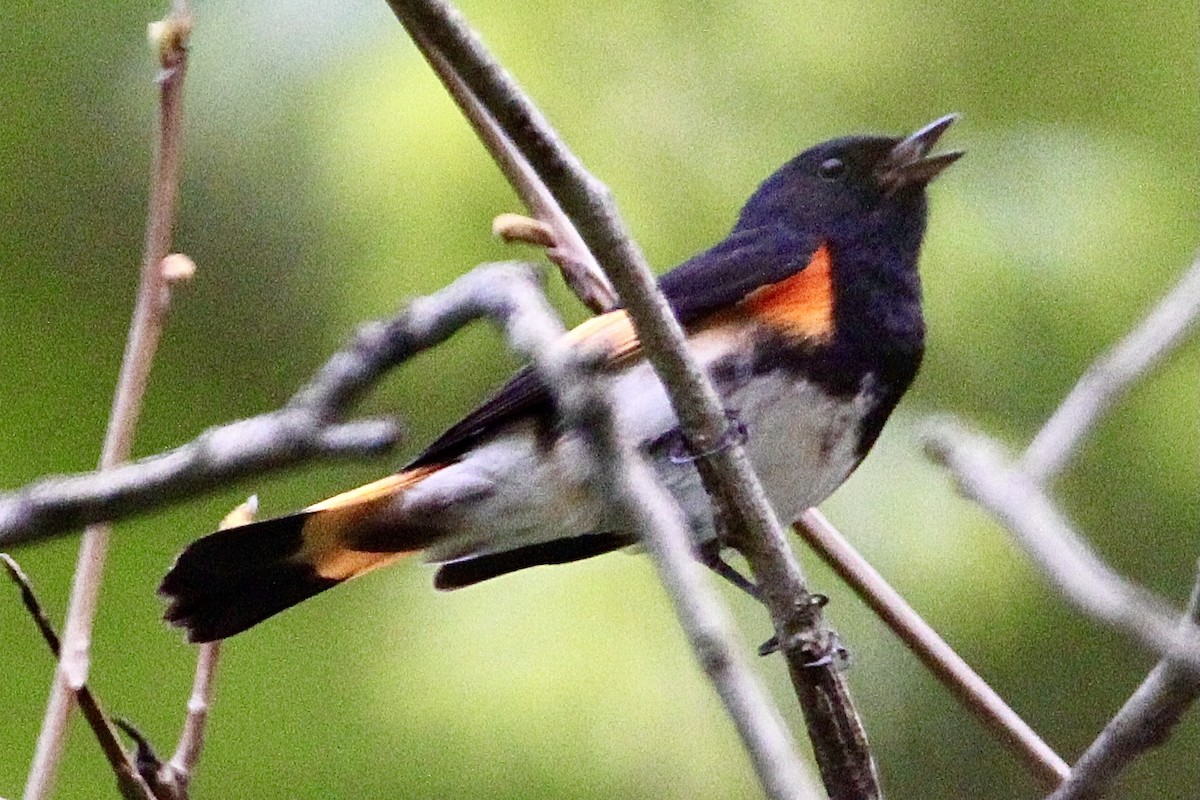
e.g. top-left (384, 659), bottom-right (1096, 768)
top-left (412, 341), bottom-right (868, 561)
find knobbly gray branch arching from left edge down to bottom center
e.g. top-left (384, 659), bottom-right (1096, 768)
top-left (11, 263), bottom-right (787, 798)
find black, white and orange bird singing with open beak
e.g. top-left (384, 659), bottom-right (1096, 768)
top-left (158, 114), bottom-right (962, 642)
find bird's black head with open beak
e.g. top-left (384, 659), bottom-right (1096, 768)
top-left (736, 114), bottom-right (962, 258)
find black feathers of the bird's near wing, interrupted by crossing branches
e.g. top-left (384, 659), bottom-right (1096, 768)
top-left (409, 225), bottom-right (820, 468)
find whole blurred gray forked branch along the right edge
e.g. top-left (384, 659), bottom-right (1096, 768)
top-left (926, 248), bottom-right (1200, 800)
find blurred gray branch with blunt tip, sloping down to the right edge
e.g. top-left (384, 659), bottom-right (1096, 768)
top-left (925, 421), bottom-right (1200, 673)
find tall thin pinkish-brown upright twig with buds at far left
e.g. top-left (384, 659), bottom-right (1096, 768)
top-left (25, 7), bottom-right (192, 800)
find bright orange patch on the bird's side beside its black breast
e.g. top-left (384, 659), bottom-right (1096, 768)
top-left (738, 245), bottom-right (834, 339)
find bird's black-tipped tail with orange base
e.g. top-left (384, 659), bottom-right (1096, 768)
top-left (158, 468), bottom-right (437, 642)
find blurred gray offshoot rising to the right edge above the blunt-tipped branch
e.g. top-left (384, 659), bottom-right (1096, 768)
top-left (1021, 250), bottom-right (1200, 481)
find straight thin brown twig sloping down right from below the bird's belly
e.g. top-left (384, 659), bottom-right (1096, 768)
top-left (794, 509), bottom-right (1070, 789)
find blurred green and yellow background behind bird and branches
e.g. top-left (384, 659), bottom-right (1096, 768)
top-left (0, 0), bottom-right (1200, 800)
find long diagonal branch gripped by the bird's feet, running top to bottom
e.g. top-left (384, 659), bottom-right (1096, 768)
top-left (389, 0), bottom-right (878, 800)
